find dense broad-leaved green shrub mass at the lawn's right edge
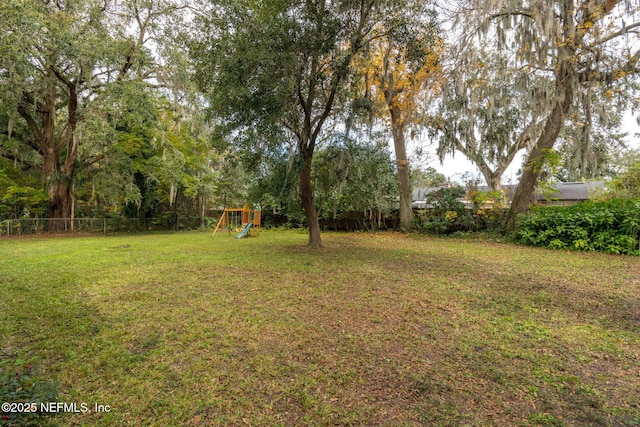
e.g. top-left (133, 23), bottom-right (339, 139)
top-left (516, 199), bottom-right (640, 255)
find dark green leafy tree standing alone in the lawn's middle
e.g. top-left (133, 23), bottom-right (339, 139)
top-left (192, 0), bottom-right (410, 247)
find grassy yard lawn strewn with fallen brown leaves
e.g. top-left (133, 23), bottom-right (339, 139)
top-left (0, 231), bottom-right (640, 426)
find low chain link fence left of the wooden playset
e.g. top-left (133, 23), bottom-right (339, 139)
top-left (0, 217), bottom-right (217, 236)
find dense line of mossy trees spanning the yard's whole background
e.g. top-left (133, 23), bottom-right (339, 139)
top-left (0, 0), bottom-right (640, 241)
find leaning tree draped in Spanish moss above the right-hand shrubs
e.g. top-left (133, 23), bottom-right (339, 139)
top-left (450, 0), bottom-right (640, 228)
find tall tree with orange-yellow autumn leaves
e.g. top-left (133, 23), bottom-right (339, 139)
top-left (362, 1), bottom-right (443, 230)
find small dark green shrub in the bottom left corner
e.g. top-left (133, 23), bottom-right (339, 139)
top-left (0, 360), bottom-right (58, 426)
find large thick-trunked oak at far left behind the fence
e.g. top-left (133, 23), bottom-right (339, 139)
top-left (0, 0), bottom-right (180, 229)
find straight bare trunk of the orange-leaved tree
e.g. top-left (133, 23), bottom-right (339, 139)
top-left (389, 106), bottom-right (413, 230)
